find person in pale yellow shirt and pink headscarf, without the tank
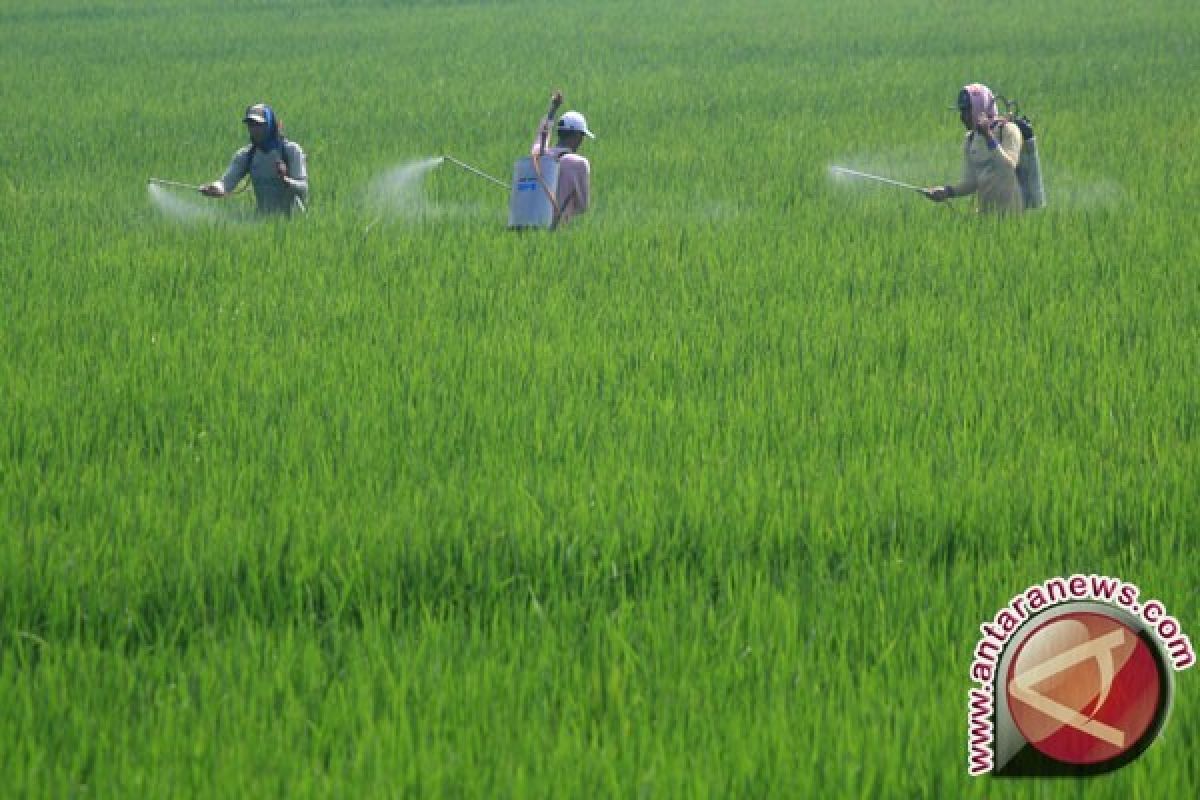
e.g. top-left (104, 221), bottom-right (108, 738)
top-left (925, 83), bottom-right (1025, 213)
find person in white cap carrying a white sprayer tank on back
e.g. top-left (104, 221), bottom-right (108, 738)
top-left (509, 91), bottom-right (595, 229)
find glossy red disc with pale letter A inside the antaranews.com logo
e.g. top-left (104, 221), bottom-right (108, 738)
top-left (1006, 612), bottom-right (1163, 764)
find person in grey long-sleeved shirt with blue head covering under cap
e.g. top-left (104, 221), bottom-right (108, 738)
top-left (200, 103), bottom-right (308, 213)
